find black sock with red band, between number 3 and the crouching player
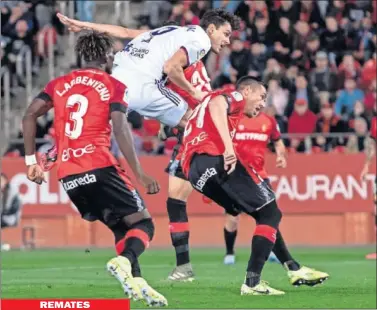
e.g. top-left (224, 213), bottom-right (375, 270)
top-left (166, 198), bottom-right (190, 266)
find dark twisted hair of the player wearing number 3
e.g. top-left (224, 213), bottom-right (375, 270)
top-left (75, 31), bottom-right (114, 62)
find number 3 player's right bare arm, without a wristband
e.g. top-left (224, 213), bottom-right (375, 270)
top-left (111, 111), bottom-right (160, 194)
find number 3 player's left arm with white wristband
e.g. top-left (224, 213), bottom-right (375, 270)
top-left (22, 96), bottom-right (53, 184)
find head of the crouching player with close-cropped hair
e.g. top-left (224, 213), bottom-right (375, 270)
top-left (236, 76), bottom-right (267, 117)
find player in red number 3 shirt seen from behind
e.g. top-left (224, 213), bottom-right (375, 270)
top-left (23, 32), bottom-right (167, 306)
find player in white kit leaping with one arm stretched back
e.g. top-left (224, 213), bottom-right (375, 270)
top-left (58, 9), bottom-right (240, 127)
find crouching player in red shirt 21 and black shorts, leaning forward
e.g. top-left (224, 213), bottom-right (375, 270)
top-left (182, 77), bottom-right (328, 295)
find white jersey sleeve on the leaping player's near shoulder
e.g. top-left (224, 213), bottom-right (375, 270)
top-left (181, 26), bottom-right (211, 66)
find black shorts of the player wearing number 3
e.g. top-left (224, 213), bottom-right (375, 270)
top-left (60, 166), bottom-right (145, 227)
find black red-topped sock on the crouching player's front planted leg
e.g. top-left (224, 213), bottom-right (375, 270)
top-left (245, 225), bottom-right (276, 287)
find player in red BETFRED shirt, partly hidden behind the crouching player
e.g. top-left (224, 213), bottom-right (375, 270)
top-left (224, 112), bottom-right (287, 265)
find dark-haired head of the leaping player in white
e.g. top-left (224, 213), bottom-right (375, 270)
top-left (200, 9), bottom-right (240, 54)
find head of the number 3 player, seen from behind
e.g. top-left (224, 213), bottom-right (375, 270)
top-left (75, 31), bottom-right (114, 73)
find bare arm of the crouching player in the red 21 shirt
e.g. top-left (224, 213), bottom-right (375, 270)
top-left (208, 96), bottom-right (237, 174)
